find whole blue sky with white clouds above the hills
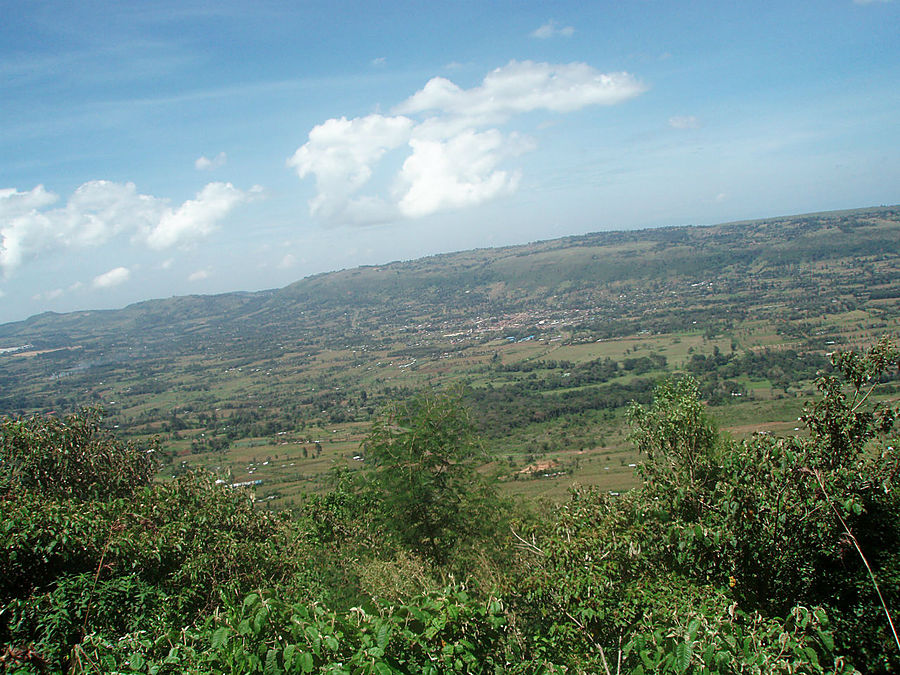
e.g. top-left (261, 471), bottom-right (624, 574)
top-left (0, 0), bottom-right (900, 322)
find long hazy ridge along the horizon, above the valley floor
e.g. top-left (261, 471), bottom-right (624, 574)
top-left (0, 207), bottom-right (900, 350)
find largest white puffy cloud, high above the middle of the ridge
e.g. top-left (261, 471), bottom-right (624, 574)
top-left (287, 61), bottom-right (645, 224)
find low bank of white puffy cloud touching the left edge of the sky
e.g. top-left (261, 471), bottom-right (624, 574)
top-left (0, 180), bottom-right (255, 276)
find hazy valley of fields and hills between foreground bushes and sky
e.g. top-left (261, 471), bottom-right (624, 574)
top-left (0, 208), bottom-right (900, 508)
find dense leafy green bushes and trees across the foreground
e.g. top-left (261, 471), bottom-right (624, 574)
top-left (0, 339), bottom-right (900, 675)
